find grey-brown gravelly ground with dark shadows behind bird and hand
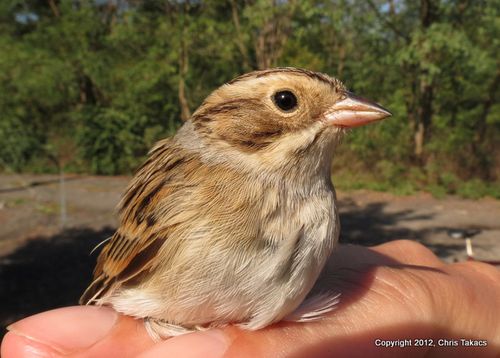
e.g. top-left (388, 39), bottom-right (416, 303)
top-left (0, 175), bottom-right (500, 335)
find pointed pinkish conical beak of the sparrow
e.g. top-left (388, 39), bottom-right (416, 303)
top-left (325, 92), bottom-right (392, 128)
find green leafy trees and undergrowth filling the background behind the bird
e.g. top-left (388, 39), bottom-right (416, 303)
top-left (0, 0), bottom-right (500, 197)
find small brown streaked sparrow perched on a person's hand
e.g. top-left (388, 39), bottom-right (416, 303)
top-left (80, 67), bottom-right (391, 340)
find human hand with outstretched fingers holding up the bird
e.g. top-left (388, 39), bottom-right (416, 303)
top-left (1, 240), bottom-right (500, 358)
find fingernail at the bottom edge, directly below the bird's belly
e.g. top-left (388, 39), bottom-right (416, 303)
top-left (139, 329), bottom-right (230, 358)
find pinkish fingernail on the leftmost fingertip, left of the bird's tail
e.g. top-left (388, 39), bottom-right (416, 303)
top-left (7, 306), bottom-right (118, 356)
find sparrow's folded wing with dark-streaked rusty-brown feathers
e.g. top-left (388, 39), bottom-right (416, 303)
top-left (80, 139), bottom-right (195, 304)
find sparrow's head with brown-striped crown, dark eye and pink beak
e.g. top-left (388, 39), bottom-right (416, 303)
top-left (180, 68), bottom-right (390, 177)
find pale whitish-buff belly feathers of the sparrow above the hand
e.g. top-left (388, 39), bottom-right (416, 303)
top-left (112, 196), bottom-right (338, 329)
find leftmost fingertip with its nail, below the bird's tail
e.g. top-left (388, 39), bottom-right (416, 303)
top-left (1, 306), bottom-right (153, 358)
